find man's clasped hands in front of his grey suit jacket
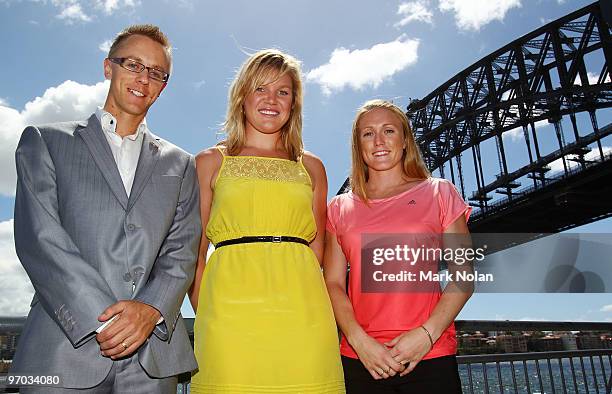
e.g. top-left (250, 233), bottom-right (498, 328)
top-left (96, 300), bottom-right (161, 360)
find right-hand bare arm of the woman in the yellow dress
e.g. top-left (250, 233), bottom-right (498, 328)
top-left (303, 152), bottom-right (327, 263)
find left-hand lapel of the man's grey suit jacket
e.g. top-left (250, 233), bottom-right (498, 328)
top-left (78, 114), bottom-right (128, 210)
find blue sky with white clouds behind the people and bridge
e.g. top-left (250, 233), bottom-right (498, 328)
top-left (0, 0), bottom-right (612, 321)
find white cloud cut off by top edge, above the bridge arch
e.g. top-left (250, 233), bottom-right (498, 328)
top-left (439, 0), bottom-right (521, 31)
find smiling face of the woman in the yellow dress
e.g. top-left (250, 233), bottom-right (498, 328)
top-left (244, 73), bottom-right (293, 134)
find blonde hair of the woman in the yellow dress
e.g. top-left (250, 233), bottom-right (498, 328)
top-left (219, 49), bottom-right (304, 160)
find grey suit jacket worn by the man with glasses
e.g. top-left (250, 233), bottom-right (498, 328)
top-left (11, 115), bottom-right (201, 388)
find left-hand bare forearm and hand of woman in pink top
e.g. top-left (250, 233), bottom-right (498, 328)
top-left (323, 232), bottom-right (404, 379)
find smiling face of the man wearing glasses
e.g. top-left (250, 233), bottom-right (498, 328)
top-left (104, 35), bottom-right (170, 116)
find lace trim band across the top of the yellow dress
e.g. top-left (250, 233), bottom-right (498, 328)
top-left (219, 156), bottom-right (310, 185)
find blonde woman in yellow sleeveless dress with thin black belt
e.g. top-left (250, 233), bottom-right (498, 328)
top-left (190, 50), bottom-right (344, 394)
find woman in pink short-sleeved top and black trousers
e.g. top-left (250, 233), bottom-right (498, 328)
top-left (324, 100), bottom-right (472, 394)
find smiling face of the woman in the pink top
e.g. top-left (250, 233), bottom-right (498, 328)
top-left (357, 108), bottom-right (406, 171)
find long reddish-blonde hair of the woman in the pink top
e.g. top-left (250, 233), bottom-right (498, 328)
top-left (351, 100), bottom-right (431, 203)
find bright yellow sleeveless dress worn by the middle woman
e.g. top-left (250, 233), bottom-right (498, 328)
top-left (191, 149), bottom-right (345, 394)
